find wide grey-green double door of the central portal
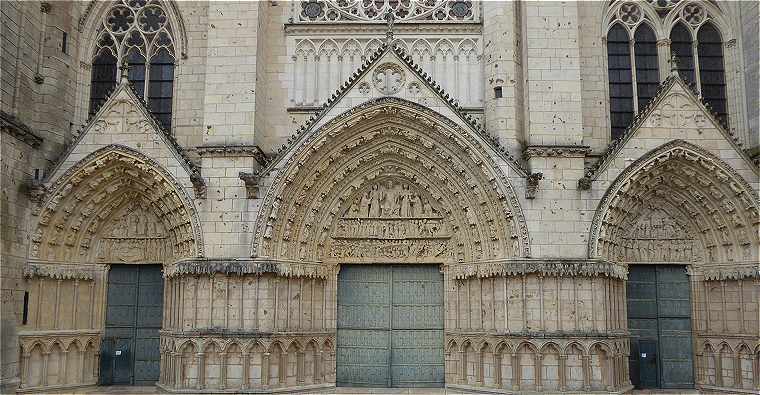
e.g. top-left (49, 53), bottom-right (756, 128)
top-left (336, 265), bottom-right (444, 387)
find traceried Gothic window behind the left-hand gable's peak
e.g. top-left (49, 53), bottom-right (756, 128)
top-left (89, 0), bottom-right (176, 129)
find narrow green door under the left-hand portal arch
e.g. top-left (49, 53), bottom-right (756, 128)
top-left (100, 265), bottom-right (164, 385)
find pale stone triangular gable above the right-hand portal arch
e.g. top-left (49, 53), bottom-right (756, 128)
top-left (586, 73), bottom-right (757, 180)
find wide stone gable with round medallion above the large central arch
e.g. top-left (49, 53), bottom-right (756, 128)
top-left (264, 43), bottom-right (527, 174)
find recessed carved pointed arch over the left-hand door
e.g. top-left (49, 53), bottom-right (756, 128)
top-left (30, 145), bottom-right (202, 263)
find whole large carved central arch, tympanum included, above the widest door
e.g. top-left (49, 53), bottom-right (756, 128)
top-left (253, 98), bottom-right (529, 264)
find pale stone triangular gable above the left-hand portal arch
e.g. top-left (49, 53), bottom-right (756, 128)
top-left (44, 77), bottom-right (200, 187)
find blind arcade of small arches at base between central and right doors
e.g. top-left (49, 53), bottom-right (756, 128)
top-left (446, 337), bottom-right (628, 392)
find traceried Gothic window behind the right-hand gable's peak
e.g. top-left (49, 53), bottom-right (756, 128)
top-left (606, 0), bottom-right (728, 139)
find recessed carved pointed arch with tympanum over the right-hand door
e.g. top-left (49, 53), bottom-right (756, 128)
top-left (589, 140), bottom-right (760, 278)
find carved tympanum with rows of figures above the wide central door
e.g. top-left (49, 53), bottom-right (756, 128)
top-left (329, 179), bottom-right (454, 262)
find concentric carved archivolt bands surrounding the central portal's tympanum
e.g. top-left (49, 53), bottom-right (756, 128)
top-left (253, 98), bottom-right (529, 262)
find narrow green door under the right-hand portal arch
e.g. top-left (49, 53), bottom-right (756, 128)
top-left (627, 265), bottom-right (694, 388)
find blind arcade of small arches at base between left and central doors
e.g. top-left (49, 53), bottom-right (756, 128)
top-left (158, 331), bottom-right (335, 393)
